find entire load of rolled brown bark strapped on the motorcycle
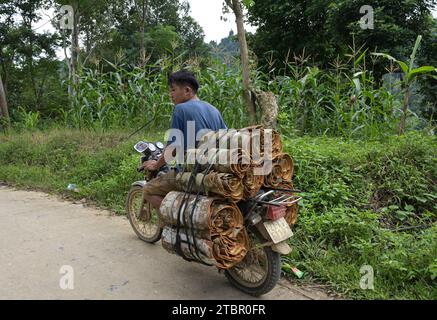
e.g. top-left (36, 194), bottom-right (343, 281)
top-left (160, 126), bottom-right (298, 269)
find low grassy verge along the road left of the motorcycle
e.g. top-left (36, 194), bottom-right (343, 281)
top-left (0, 129), bottom-right (163, 214)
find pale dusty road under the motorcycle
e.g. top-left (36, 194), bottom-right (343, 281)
top-left (0, 186), bottom-right (329, 300)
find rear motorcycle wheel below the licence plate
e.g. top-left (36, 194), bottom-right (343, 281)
top-left (225, 236), bottom-right (281, 297)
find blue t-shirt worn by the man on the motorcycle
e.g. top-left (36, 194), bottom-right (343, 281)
top-left (168, 100), bottom-right (227, 151)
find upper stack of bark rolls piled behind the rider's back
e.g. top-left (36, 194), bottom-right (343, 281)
top-left (176, 126), bottom-right (293, 202)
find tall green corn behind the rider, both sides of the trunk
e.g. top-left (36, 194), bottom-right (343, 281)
top-left (63, 49), bottom-right (423, 138)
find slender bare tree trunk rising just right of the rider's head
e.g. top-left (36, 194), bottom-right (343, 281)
top-left (226, 0), bottom-right (256, 124)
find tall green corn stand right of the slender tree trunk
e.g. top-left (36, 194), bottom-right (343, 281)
top-left (252, 48), bottom-right (396, 138)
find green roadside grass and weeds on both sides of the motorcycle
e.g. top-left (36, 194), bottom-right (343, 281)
top-left (0, 129), bottom-right (437, 299)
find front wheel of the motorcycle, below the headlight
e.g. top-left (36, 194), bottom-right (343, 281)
top-left (126, 186), bottom-right (162, 243)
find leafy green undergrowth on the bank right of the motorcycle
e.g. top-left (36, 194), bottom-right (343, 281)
top-left (286, 133), bottom-right (437, 299)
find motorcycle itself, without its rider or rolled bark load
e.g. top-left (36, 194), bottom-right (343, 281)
top-left (126, 141), bottom-right (301, 296)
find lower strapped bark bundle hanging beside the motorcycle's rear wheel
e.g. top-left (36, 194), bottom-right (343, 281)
top-left (160, 191), bottom-right (249, 269)
